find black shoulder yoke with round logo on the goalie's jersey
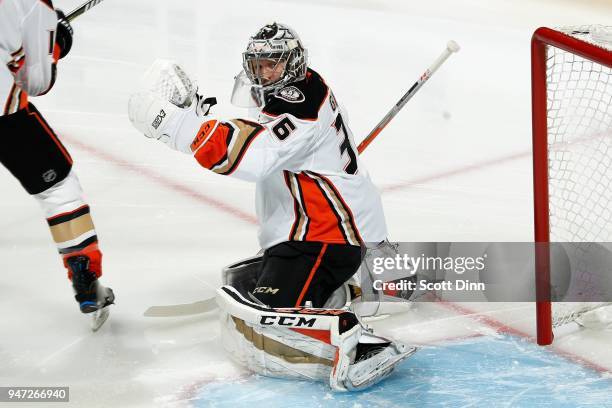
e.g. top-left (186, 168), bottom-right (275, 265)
top-left (263, 68), bottom-right (329, 120)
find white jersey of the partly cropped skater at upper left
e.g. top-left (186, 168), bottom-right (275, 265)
top-left (0, 0), bottom-right (59, 116)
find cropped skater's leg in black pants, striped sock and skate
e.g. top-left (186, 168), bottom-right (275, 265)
top-left (0, 104), bottom-right (114, 327)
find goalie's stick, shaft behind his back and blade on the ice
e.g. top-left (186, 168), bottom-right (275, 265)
top-left (142, 39), bottom-right (460, 317)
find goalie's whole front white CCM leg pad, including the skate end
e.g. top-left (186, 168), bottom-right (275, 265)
top-left (217, 286), bottom-right (417, 391)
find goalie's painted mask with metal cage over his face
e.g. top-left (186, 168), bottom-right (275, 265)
top-left (242, 23), bottom-right (308, 105)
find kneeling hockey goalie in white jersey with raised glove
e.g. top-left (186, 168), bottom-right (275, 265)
top-left (128, 23), bottom-right (416, 390)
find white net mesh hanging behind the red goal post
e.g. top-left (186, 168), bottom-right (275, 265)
top-left (547, 26), bottom-right (612, 327)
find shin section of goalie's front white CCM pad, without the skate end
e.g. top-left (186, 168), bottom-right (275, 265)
top-left (217, 286), bottom-right (361, 380)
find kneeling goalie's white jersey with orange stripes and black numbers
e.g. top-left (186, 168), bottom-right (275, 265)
top-left (130, 69), bottom-right (387, 249)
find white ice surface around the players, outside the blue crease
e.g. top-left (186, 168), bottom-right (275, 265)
top-left (0, 0), bottom-right (612, 407)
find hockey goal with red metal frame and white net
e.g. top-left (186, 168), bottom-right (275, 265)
top-left (531, 26), bottom-right (612, 345)
